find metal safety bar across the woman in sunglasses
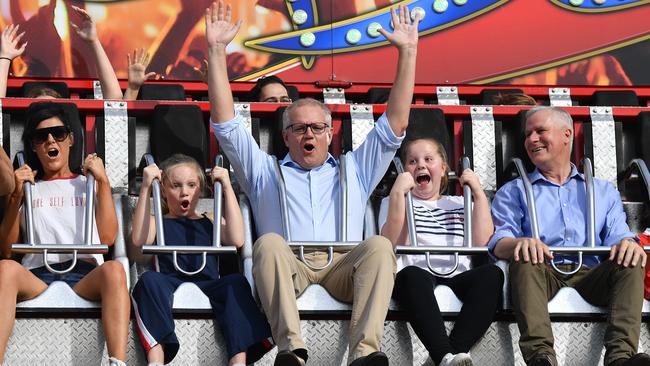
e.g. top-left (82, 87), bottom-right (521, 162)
top-left (11, 151), bottom-right (108, 274)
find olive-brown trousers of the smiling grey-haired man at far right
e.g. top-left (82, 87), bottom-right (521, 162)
top-left (510, 260), bottom-right (644, 365)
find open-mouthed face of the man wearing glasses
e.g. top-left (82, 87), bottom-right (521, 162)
top-left (282, 105), bottom-right (332, 169)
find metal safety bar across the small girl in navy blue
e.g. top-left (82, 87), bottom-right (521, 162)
top-left (140, 154), bottom-right (237, 276)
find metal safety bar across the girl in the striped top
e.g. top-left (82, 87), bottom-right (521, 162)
top-left (393, 156), bottom-right (480, 277)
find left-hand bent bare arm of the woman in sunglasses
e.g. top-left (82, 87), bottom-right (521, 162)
top-left (0, 165), bottom-right (36, 258)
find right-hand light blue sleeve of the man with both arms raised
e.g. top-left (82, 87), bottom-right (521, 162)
top-left (350, 113), bottom-right (406, 192)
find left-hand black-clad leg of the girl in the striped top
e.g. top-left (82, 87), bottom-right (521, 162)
top-left (393, 266), bottom-right (456, 365)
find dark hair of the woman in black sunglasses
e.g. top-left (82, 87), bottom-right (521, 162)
top-left (22, 102), bottom-right (78, 179)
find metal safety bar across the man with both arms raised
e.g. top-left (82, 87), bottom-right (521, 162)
top-left (273, 154), bottom-right (359, 271)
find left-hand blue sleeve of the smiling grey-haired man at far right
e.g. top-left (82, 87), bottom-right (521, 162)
top-left (488, 180), bottom-right (525, 258)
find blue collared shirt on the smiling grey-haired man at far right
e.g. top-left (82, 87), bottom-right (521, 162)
top-left (488, 164), bottom-right (635, 267)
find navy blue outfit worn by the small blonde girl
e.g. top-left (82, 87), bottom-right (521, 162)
top-left (131, 215), bottom-right (272, 363)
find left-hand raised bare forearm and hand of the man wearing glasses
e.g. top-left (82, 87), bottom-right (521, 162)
top-left (205, 1), bottom-right (242, 123)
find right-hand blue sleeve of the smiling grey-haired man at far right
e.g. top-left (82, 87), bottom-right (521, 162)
top-left (599, 182), bottom-right (636, 246)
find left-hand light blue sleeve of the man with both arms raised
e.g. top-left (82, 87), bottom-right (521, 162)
top-left (210, 113), bottom-right (270, 197)
